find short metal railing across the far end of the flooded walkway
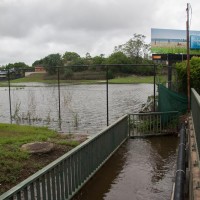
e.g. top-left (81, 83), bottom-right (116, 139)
top-left (129, 111), bottom-right (178, 137)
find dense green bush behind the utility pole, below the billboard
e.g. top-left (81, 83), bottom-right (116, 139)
top-left (176, 57), bottom-right (200, 94)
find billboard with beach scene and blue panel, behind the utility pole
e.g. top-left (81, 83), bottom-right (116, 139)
top-left (151, 28), bottom-right (200, 54)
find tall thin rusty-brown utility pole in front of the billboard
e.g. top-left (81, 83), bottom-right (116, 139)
top-left (186, 3), bottom-right (190, 112)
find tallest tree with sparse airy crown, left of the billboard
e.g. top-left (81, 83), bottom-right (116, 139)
top-left (115, 33), bottom-right (150, 64)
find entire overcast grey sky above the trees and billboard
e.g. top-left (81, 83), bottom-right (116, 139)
top-left (0, 0), bottom-right (200, 66)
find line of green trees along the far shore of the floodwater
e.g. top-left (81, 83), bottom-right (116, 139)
top-left (0, 34), bottom-right (153, 78)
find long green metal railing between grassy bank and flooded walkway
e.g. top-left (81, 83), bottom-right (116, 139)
top-left (0, 115), bottom-right (128, 200)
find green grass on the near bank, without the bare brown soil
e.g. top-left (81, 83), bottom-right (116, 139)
top-left (0, 124), bottom-right (79, 194)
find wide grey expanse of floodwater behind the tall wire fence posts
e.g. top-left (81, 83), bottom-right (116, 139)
top-left (0, 83), bottom-right (153, 133)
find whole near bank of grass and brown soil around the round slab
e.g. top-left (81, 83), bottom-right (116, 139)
top-left (0, 124), bottom-right (82, 194)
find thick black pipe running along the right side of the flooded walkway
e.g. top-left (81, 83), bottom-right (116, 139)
top-left (173, 124), bottom-right (186, 200)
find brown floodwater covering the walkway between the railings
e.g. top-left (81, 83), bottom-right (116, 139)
top-left (73, 136), bottom-right (178, 200)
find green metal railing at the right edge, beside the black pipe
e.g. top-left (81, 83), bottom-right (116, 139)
top-left (191, 88), bottom-right (200, 157)
